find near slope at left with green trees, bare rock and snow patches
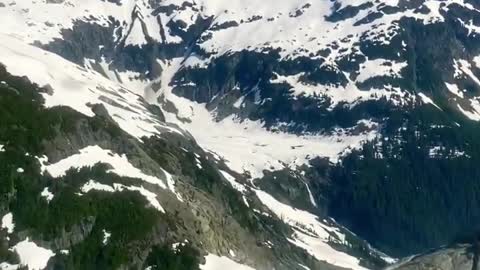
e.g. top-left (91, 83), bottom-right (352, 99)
top-left (0, 32), bottom-right (384, 269)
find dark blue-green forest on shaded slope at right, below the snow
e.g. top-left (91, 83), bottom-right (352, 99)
top-left (326, 106), bottom-right (480, 256)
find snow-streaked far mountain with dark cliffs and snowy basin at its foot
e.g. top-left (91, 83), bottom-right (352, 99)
top-left (0, 0), bottom-right (479, 176)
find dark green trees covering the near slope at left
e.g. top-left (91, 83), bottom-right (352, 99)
top-left (0, 65), bottom-right (194, 270)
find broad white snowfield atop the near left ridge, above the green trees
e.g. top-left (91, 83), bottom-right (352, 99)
top-left (0, 33), bottom-right (178, 138)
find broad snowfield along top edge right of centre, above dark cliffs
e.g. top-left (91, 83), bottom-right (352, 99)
top-left (164, 0), bottom-right (474, 57)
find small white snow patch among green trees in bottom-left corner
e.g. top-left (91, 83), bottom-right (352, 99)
top-left (12, 238), bottom-right (55, 270)
